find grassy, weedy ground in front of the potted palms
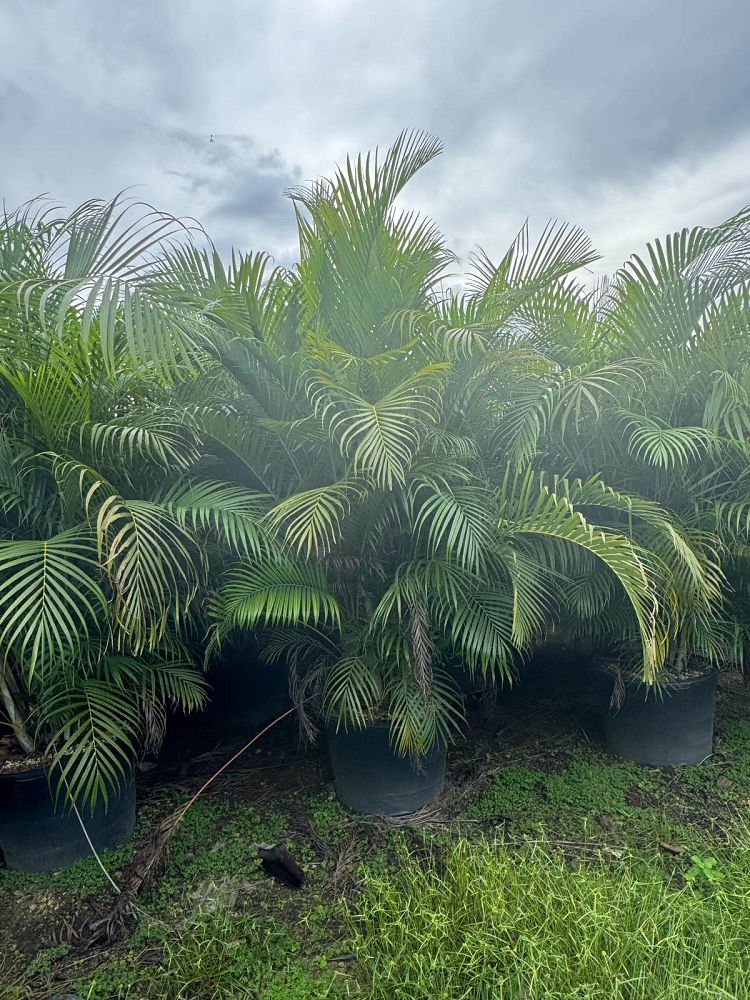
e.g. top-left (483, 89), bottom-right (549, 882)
top-left (0, 678), bottom-right (750, 1000)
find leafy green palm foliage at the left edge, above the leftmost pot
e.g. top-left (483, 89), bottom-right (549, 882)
top-left (0, 199), bottom-right (270, 808)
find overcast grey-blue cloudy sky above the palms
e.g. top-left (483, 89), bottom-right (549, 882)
top-left (0, 0), bottom-right (750, 270)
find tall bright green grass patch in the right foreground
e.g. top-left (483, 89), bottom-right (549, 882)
top-left (353, 841), bottom-right (750, 1000)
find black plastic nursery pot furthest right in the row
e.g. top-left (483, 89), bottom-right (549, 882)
top-left (604, 671), bottom-right (718, 767)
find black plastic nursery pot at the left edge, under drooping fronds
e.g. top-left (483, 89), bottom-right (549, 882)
top-left (0, 767), bottom-right (135, 872)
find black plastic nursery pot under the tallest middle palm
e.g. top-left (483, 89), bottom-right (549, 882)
top-left (326, 722), bottom-right (446, 816)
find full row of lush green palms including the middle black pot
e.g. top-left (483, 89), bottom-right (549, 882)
top-left (0, 133), bottom-right (750, 865)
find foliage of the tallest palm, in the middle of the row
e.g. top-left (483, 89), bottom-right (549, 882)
top-left (154, 134), bottom-right (667, 752)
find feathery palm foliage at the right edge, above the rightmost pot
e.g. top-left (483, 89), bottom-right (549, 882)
top-left (496, 209), bottom-right (750, 667)
